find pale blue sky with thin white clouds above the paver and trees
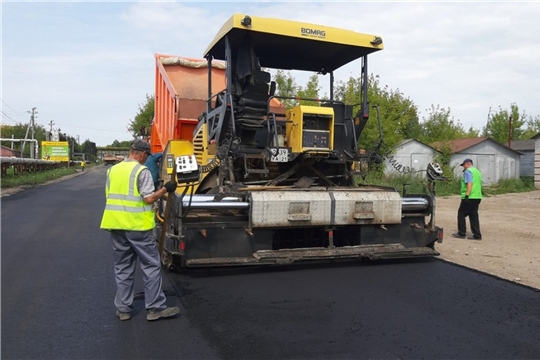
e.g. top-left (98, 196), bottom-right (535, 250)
top-left (0, 1), bottom-right (540, 146)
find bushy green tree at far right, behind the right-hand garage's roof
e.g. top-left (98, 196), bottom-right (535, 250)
top-left (483, 104), bottom-right (527, 144)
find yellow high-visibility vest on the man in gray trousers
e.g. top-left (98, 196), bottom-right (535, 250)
top-left (101, 161), bottom-right (156, 231)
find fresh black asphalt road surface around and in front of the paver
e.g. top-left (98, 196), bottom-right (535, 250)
top-left (1, 167), bottom-right (540, 359)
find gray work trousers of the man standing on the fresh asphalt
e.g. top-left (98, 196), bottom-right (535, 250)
top-left (111, 230), bottom-right (167, 312)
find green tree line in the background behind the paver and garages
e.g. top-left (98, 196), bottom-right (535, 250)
top-left (40, 70), bottom-right (540, 151)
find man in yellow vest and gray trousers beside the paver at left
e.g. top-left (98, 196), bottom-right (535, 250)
top-left (101, 139), bottom-right (180, 321)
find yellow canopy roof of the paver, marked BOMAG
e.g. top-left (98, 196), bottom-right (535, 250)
top-left (204, 14), bottom-right (383, 73)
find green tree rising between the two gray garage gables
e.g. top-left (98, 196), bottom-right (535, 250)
top-left (419, 105), bottom-right (471, 144)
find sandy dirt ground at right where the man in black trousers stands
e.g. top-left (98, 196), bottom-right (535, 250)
top-left (435, 190), bottom-right (540, 289)
